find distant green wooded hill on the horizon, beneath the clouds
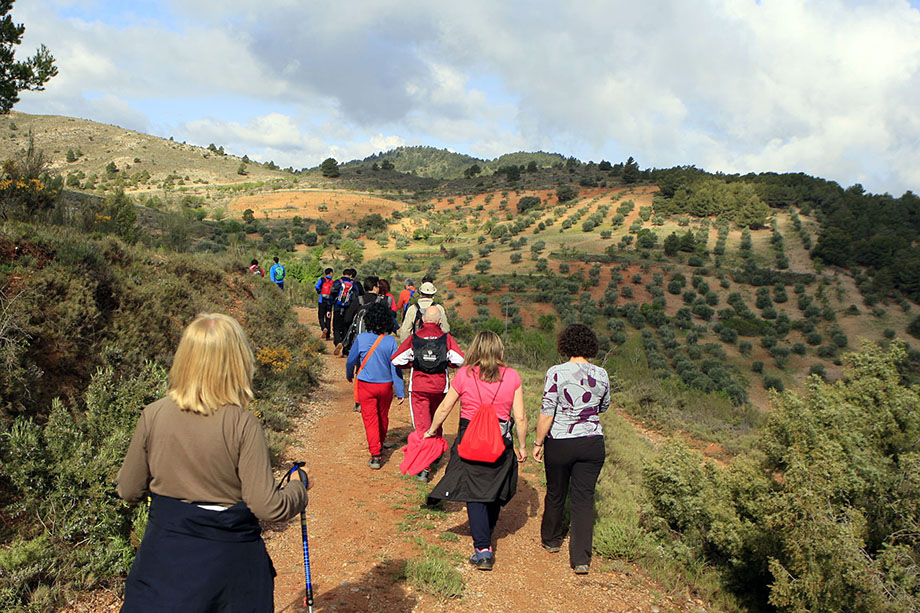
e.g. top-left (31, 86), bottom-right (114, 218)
top-left (342, 146), bottom-right (565, 180)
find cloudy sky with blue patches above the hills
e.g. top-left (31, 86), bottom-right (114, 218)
top-left (12, 0), bottom-right (920, 196)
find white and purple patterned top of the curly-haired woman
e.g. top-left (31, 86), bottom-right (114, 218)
top-left (540, 362), bottom-right (610, 439)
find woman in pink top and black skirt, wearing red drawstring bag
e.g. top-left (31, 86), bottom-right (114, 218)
top-left (425, 330), bottom-right (527, 570)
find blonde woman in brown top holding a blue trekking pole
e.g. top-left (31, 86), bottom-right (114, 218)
top-left (118, 314), bottom-right (307, 612)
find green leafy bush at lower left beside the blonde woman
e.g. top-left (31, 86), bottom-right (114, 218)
top-left (0, 362), bottom-right (166, 608)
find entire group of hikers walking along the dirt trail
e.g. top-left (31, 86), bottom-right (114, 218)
top-left (118, 258), bottom-right (610, 611)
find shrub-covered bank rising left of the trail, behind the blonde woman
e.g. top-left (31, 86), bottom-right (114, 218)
top-left (0, 215), bottom-right (322, 611)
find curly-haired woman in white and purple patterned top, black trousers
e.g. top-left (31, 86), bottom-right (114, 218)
top-left (533, 324), bottom-right (610, 575)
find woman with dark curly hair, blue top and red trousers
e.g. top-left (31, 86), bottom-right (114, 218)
top-left (345, 302), bottom-right (405, 470)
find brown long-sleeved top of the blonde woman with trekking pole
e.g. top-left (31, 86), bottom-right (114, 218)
top-left (118, 397), bottom-right (307, 521)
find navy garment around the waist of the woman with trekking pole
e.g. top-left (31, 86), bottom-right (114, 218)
top-left (121, 495), bottom-right (275, 613)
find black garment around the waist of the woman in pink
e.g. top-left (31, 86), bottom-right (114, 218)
top-left (428, 418), bottom-right (518, 506)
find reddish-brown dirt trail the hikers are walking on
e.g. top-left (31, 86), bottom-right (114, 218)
top-left (264, 309), bottom-right (681, 613)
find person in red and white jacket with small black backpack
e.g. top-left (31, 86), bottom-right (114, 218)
top-left (392, 305), bottom-right (463, 481)
